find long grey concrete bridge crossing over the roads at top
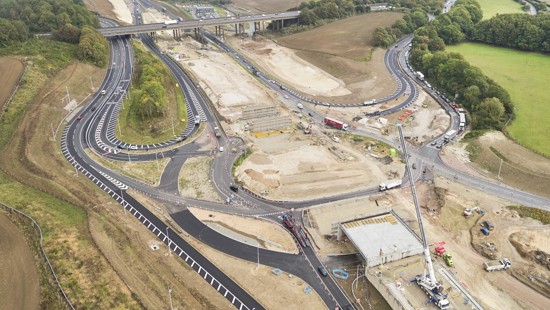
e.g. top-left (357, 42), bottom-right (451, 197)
top-left (97, 11), bottom-right (300, 37)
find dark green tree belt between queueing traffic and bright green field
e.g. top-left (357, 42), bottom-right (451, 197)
top-left (409, 0), bottom-right (514, 129)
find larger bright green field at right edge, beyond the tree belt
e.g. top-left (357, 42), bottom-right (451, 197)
top-left (446, 43), bottom-right (550, 156)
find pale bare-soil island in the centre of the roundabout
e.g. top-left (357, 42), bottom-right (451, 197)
top-left (235, 133), bottom-right (403, 200)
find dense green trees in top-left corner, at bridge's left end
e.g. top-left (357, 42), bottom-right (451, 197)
top-left (0, 0), bottom-right (109, 66)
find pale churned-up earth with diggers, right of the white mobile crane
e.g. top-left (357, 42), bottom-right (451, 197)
top-left (432, 179), bottom-right (550, 309)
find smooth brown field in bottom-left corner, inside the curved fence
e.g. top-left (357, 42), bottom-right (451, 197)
top-left (0, 213), bottom-right (40, 309)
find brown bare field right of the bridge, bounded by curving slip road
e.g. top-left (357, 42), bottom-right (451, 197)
top-left (277, 12), bottom-right (403, 103)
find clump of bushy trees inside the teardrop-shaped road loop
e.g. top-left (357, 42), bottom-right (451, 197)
top-left (131, 45), bottom-right (172, 120)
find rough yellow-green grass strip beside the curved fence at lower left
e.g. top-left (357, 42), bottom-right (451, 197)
top-left (0, 172), bottom-right (140, 309)
